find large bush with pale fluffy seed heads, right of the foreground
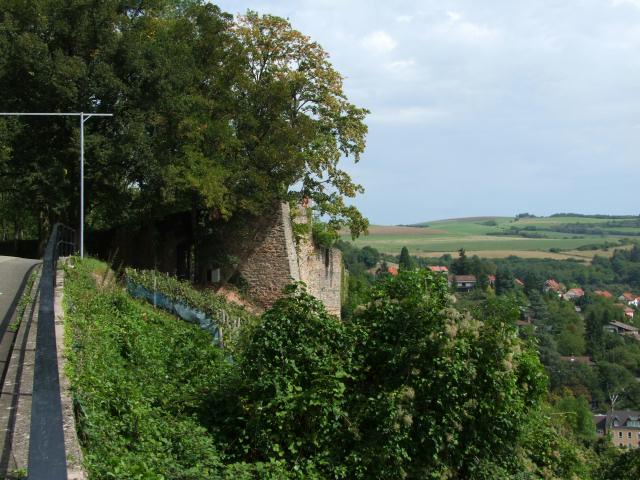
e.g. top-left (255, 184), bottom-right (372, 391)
top-left (350, 271), bottom-right (546, 478)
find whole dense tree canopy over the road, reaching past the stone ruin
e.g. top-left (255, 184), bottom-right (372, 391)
top-left (0, 0), bottom-right (368, 244)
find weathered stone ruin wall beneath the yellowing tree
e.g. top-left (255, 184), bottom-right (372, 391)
top-left (240, 204), bottom-right (342, 317)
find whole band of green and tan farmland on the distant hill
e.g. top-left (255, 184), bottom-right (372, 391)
top-left (343, 216), bottom-right (640, 259)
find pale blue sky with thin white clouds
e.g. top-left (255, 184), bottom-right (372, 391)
top-left (214, 0), bottom-right (640, 225)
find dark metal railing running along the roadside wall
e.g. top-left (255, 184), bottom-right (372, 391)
top-left (28, 223), bottom-right (77, 480)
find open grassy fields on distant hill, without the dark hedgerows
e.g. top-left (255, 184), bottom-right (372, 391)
top-left (344, 216), bottom-right (640, 259)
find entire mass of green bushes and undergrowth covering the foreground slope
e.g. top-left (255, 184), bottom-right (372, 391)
top-left (65, 259), bottom-right (596, 480)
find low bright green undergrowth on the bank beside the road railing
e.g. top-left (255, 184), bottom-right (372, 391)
top-left (64, 259), bottom-right (229, 479)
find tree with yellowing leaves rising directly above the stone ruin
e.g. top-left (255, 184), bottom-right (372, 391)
top-left (234, 11), bottom-right (368, 235)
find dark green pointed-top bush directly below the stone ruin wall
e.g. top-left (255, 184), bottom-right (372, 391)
top-left (234, 284), bottom-right (353, 476)
